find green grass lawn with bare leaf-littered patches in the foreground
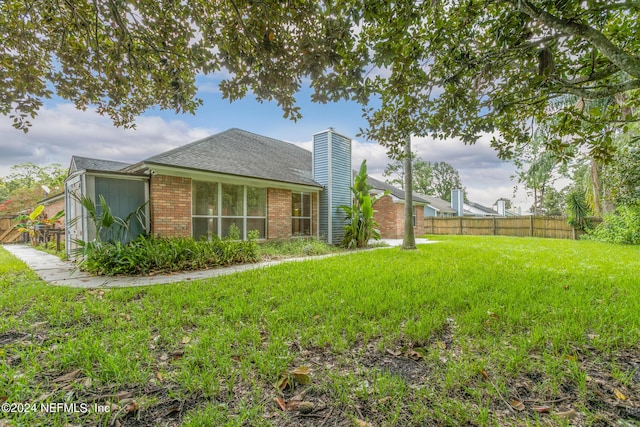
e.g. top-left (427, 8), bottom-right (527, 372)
top-left (0, 236), bottom-right (640, 426)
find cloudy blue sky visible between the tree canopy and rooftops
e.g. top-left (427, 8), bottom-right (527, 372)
top-left (0, 78), bottom-right (531, 210)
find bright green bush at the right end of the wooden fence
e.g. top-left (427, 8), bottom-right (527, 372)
top-left (589, 203), bottom-right (640, 245)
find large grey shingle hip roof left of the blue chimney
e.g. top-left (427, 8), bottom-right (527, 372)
top-left (143, 129), bottom-right (321, 187)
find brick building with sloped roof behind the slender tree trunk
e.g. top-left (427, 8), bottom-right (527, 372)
top-left (367, 177), bottom-right (427, 239)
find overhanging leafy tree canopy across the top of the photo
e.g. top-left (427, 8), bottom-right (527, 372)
top-left (0, 0), bottom-right (640, 157)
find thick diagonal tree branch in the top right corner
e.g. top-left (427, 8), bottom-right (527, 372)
top-left (509, 0), bottom-right (640, 78)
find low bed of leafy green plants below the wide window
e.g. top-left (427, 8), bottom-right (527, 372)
top-left (82, 233), bottom-right (260, 276)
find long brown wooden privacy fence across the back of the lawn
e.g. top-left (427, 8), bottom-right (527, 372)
top-left (424, 216), bottom-right (596, 239)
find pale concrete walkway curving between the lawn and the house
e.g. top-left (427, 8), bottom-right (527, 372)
top-left (3, 239), bottom-right (435, 288)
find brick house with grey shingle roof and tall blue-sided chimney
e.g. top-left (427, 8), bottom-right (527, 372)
top-left (65, 129), bottom-right (360, 251)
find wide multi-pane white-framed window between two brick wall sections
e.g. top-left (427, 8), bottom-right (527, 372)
top-left (191, 181), bottom-right (267, 240)
